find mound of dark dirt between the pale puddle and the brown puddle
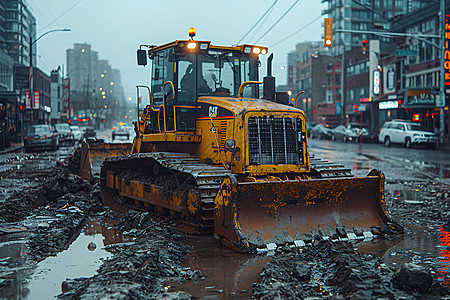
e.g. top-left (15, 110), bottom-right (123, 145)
top-left (59, 211), bottom-right (197, 299)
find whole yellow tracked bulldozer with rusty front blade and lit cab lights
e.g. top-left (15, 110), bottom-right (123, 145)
top-left (82, 28), bottom-right (402, 253)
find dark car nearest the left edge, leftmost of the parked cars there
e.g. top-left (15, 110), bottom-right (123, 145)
top-left (23, 125), bottom-right (59, 153)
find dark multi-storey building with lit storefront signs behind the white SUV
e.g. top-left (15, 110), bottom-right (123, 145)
top-left (375, 1), bottom-right (450, 135)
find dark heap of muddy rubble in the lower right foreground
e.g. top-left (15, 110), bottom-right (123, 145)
top-left (253, 241), bottom-right (449, 299)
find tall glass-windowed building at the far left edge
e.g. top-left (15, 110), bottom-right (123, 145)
top-left (0, 0), bottom-right (36, 146)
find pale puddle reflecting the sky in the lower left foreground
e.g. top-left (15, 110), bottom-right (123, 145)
top-left (0, 220), bottom-right (123, 299)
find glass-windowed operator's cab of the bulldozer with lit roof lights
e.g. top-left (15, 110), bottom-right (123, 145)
top-left (138, 40), bottom-right (267, 133)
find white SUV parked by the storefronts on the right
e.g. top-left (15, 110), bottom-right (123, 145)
top-left (378, 120), bottom-right (437, 148)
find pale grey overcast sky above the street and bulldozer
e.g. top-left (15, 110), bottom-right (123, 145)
top-left (27, 0), bottom-right (325, 99)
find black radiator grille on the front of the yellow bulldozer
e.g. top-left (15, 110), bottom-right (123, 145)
top-left (248, 117), bottom-right (305, 165)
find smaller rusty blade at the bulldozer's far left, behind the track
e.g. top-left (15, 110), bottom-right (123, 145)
top-left (79, 140), bottom-right (132, 181)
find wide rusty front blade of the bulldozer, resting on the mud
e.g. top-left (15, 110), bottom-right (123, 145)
top-left (214, 172), bottom-right (403, 252)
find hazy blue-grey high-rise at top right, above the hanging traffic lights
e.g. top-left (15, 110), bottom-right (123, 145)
top-left (322, 0), bottom-right (438, 54)
